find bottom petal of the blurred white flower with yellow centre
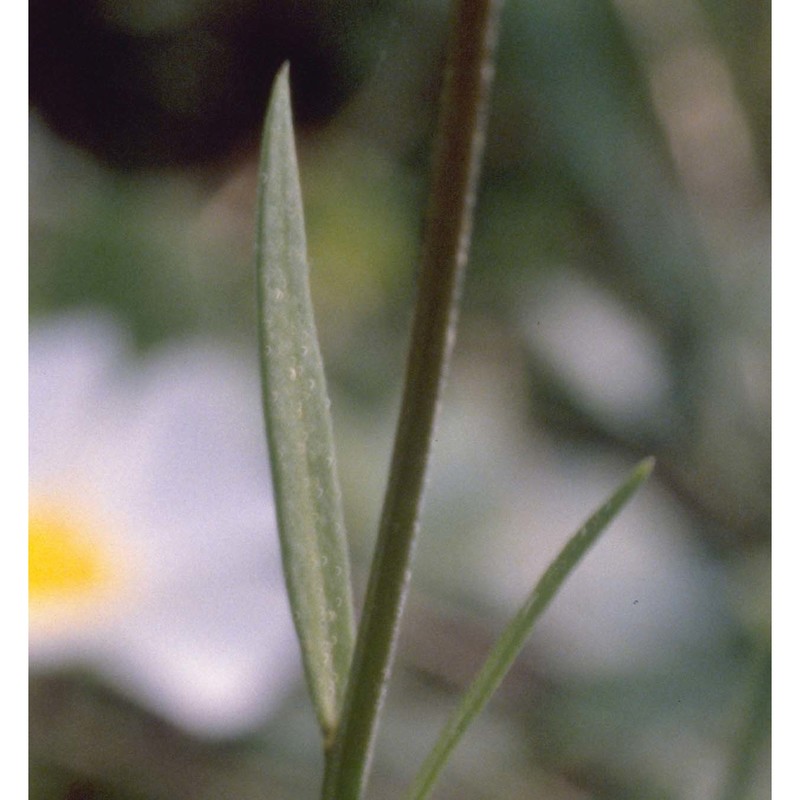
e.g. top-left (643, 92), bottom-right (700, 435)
top-left (98, 583), bottom-right (300, 737)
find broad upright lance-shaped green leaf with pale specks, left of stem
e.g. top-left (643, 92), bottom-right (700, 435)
top-left (256, 65), bottom-right (354, 742)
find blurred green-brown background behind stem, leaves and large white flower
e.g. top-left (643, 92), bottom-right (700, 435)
top-left (29, 0), bottom-right (771, 800)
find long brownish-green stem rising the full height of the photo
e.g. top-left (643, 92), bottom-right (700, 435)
top-left (323, 0), bottom-right (501, 800)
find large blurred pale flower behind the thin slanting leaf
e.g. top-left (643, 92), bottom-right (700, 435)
top-left (410, 347), bottom-right (732, 680)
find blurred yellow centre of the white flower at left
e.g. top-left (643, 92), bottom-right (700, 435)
top-left (28, 502), bottom-right (129, 625)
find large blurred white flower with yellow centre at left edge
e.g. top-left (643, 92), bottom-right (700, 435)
top-left (29, 316), bottom-right (300, 736)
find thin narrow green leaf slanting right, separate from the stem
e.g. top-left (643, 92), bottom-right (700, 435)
top-left (408, 458), bottom-right (654, 800)
